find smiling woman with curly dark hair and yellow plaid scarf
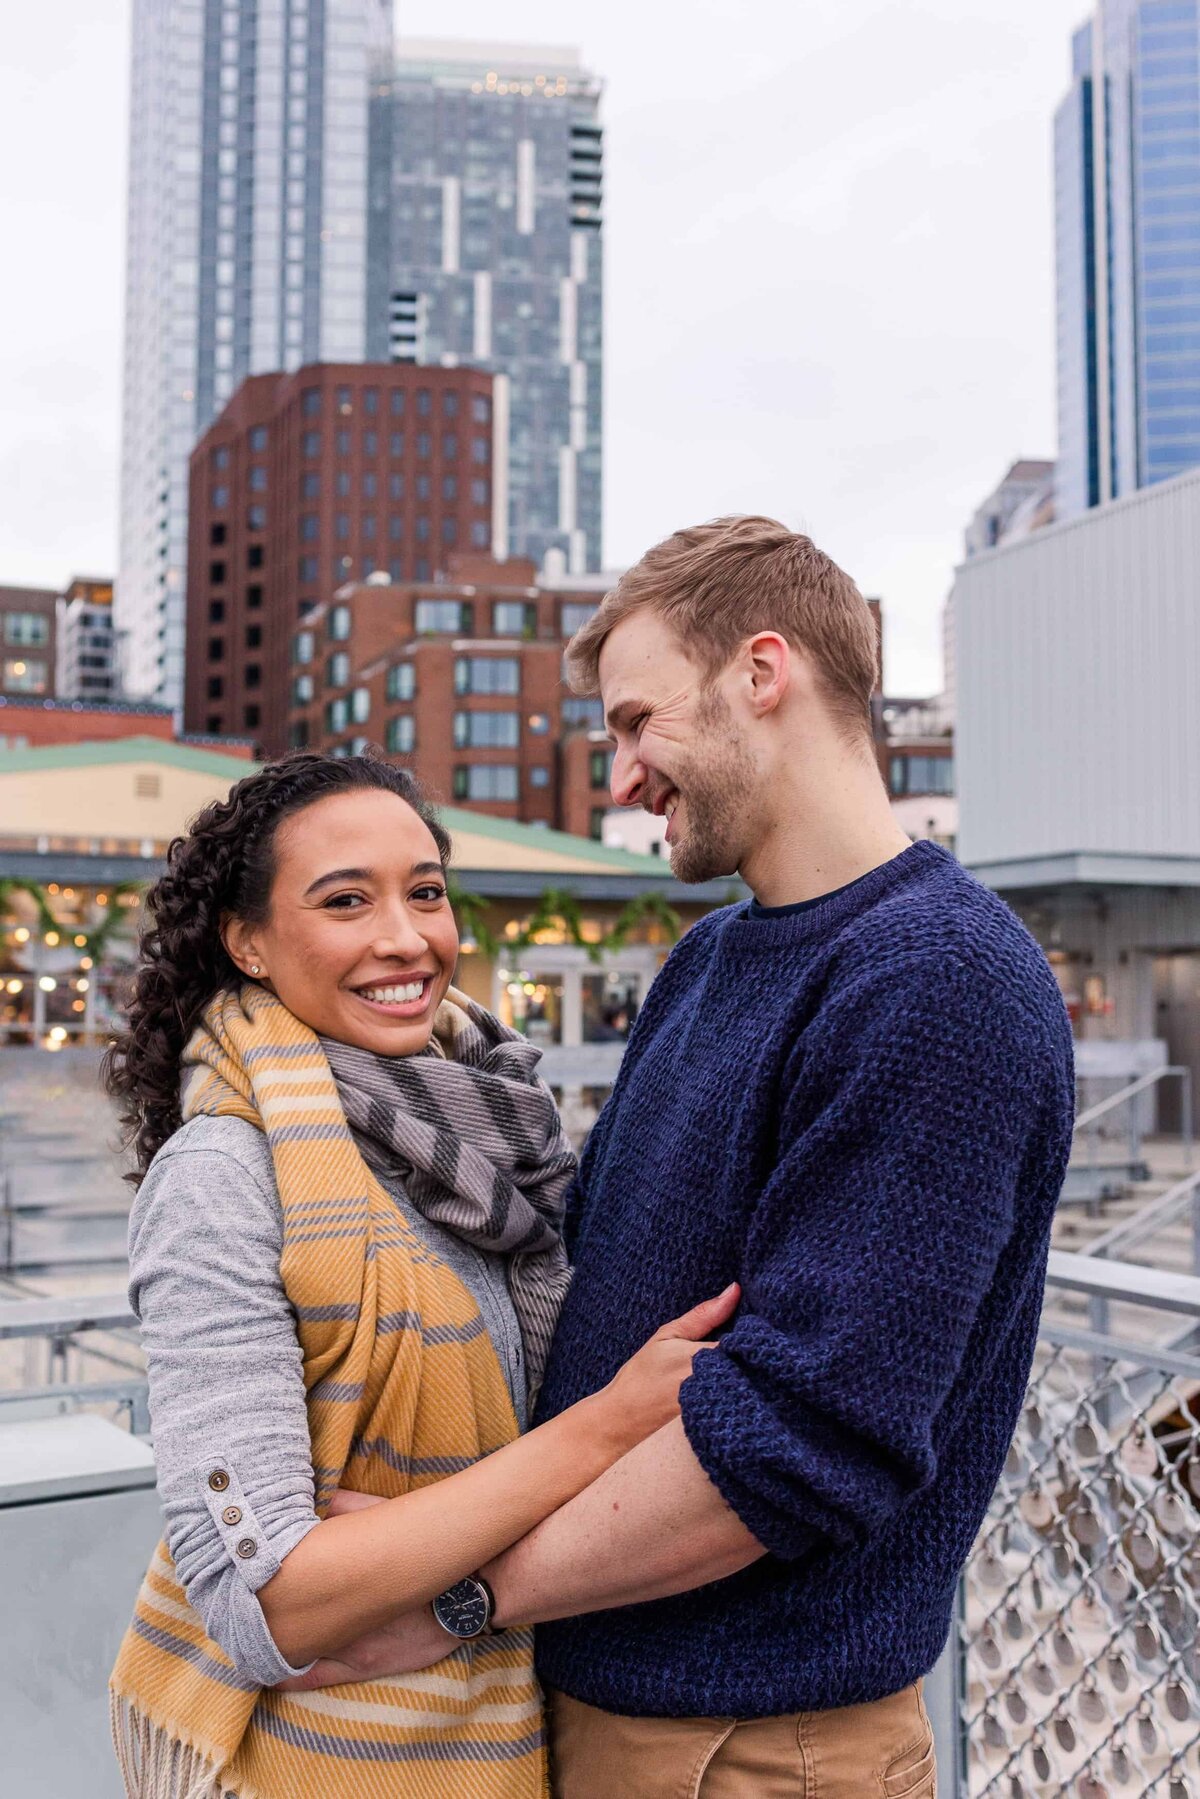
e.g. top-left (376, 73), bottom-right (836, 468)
top-left (106, 756), bottom-right (732, 1799)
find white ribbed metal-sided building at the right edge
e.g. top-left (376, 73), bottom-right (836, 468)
top-left (952, 471), bottom-right (1200, 1123)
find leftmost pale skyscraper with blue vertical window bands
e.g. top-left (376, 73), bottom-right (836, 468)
top-left (115, 0), bottom-right (392, 707)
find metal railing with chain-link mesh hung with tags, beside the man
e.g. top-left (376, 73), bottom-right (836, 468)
top-left (928, 1254), bottom-right (1200, 1799)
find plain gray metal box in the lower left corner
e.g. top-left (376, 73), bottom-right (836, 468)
top-left (0, 1412), bottom-right (162, 1799)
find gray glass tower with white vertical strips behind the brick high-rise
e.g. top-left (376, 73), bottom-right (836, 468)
top-left (367, 40), bottom-right (603, 574)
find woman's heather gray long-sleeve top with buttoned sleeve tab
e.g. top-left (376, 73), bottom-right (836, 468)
top-left (130, 1117), bottom-right (525, 1686)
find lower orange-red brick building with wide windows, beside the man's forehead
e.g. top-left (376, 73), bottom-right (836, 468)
top-left (290, 558), bottom-right (608, 837)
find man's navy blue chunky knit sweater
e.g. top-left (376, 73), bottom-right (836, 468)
top-left (538, 844), bottom-right (1074, 1716)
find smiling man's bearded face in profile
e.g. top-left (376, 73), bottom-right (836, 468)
top-left (599, 610), bottom-right (757, 882)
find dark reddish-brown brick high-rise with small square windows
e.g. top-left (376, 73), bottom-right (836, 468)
top-left (184, 363), bottom-right (507, 756)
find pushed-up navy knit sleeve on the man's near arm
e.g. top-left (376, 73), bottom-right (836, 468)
top-left (680, 959), bottom-right (1051, 1558)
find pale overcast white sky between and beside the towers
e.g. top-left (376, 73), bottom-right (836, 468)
top-left (0, 0), bottom-right (1087, 693)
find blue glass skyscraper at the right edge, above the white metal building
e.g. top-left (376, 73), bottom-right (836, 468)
top-left (1054, 0), bottom-right (1200, 518)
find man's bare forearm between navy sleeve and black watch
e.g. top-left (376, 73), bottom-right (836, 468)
top-left (484, 1419), bottom-right (765, 1624)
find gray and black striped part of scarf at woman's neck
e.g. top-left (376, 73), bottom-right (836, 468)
top-left (320, 988), bottom-right (576, 1410)
